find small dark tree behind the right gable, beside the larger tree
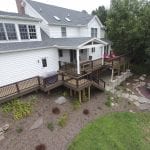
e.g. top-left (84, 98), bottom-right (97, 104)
top-left (92, 6), bottom-right (107, 25)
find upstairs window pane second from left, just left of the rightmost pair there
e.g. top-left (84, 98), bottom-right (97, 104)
top-left (5, 23), bottom-right (17, 40)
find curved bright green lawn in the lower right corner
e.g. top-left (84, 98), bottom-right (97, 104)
top-left (68, 112), bottom-right (150, 150)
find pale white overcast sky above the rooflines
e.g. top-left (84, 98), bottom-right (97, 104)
top-left (0, 0), bottom-right (110, 13)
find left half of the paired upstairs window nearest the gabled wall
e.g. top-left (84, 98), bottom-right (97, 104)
top-left (19, 24), bottom-right (29, 40)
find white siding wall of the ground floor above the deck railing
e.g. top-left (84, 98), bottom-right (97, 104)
top-left (0, 48), bottom-right (59, 86)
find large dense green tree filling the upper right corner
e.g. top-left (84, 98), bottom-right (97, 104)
top-left (106, 0), bottom-right (150, 63)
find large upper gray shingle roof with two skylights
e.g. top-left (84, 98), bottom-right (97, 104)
top-left (27, 0), bottom-right (93, 26)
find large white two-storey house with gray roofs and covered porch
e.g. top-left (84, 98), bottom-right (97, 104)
top-left (0, 0), bottom-right (123, 103)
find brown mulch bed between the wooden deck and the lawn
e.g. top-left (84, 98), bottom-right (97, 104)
top-left (0, 91), bottom-right (139, 150)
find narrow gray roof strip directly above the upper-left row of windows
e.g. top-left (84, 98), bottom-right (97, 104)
top-left (0, 11), bottom-right (39, 20)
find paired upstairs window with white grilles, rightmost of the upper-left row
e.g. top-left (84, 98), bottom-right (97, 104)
top-left (19, 24), bottom-right (37, 40)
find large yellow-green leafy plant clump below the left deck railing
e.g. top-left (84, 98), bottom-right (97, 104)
top-left (2, 99), bottom-right (32, 120)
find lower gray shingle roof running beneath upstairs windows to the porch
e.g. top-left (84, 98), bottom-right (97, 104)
top-left (0, 31), bottom-right (92, 53)
